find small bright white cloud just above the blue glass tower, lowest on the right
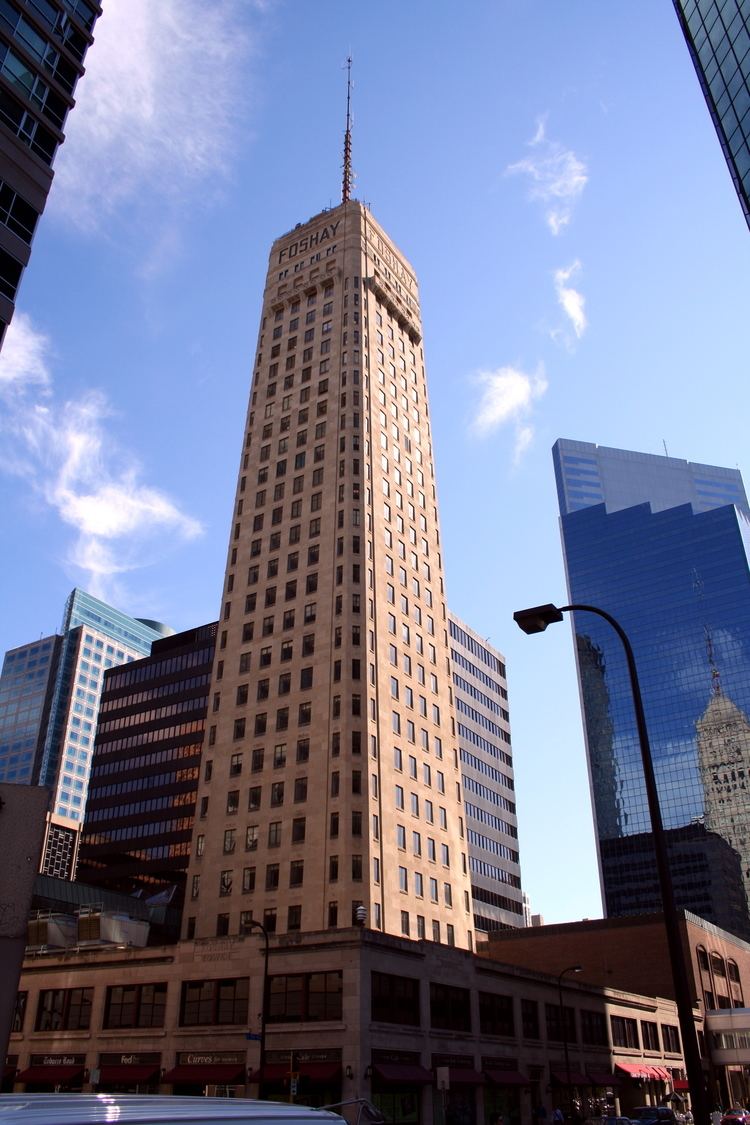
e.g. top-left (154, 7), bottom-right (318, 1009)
top-left (472, 363), bottom-right (549, 464)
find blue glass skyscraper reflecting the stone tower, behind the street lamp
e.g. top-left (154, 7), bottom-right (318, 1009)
top-left (553, 441), bottom-right (750, 937)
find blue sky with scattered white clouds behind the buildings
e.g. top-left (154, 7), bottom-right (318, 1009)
top-left (0, 0), bottom-right (750, 921)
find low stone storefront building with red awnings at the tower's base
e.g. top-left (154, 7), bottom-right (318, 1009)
top-left (6, 928), bottom-right (684, 1125)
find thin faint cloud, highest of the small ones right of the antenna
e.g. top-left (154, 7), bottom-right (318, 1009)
top-left (505, 118), bottom-right (588, 235)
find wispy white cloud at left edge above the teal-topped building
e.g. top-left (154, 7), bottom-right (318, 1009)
top-left (0, 313), bottom-right (202, 597)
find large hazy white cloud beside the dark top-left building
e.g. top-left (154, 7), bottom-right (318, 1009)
top-left (51, 0), bottom-right (262, 230)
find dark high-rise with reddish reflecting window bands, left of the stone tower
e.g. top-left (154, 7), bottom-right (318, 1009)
top-left (78, 624), bottom-right (216, 922)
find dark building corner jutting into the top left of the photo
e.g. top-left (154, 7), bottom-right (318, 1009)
top-left (0, 0), bottom-right (101, 347)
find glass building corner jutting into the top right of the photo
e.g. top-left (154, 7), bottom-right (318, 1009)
top-left (674, 0), bottom-right (750, 226)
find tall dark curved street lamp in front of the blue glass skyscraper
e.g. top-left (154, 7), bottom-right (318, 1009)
top-left (513, 605), bottom-right (710, 1125)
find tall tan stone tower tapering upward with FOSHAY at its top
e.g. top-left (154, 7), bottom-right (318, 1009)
top-left (184, 202), bottom-right (472, 947)
